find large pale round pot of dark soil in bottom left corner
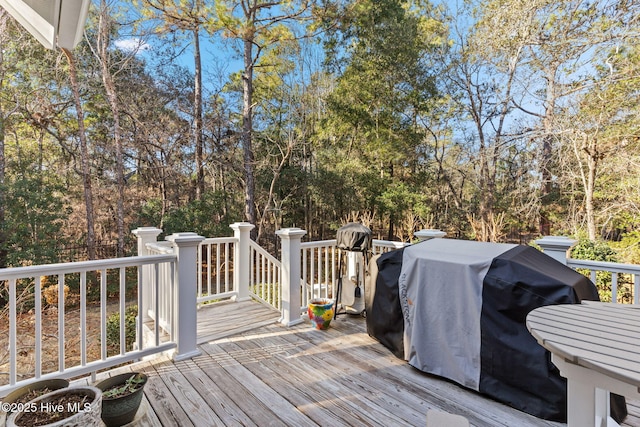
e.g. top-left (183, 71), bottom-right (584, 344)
top-left (7, 386), bottom-right (102, 427)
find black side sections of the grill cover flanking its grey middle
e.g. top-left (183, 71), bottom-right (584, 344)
top-left (365, 242), bottom-right (625, 421)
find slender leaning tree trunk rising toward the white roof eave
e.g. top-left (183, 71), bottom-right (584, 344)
top-left (62, 48), bottom-right (96, 260)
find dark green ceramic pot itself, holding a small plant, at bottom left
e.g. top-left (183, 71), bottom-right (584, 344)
top-left (96, 372), bottom-right (147, 427)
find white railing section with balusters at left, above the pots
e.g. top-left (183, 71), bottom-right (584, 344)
top-left (0, 255), bottom-right (176, 393)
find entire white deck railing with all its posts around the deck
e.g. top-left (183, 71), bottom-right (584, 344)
top-left (5, 223), bottom-right (640, 394)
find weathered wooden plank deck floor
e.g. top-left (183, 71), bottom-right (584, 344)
top-left (86, 302), bottom-right (640, 427)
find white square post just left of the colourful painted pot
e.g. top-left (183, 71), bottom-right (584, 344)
top-left (276, 228), bottom-right (307, 326)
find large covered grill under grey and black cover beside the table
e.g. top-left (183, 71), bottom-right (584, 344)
top-left (365, 239), bottom-right (628, 420)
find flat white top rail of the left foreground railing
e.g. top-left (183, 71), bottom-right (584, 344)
top-left (0, 255), bottom-right (176, 280)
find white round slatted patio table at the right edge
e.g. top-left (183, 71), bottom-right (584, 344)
top-left (526, 301), bottom-right (640, 427)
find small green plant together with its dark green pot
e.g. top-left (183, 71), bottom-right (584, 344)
top-left (96, 373), bottom-right (147, 427)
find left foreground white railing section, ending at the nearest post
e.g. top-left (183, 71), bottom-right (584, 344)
top-left (0, 255), bottom-right (176, 394)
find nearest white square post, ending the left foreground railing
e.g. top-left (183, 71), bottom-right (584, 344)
top-left (166, 233), bottom-right (204, 360)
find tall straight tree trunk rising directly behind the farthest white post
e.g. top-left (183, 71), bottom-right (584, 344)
top-left (242, 39), bottom-right (257, 239)
